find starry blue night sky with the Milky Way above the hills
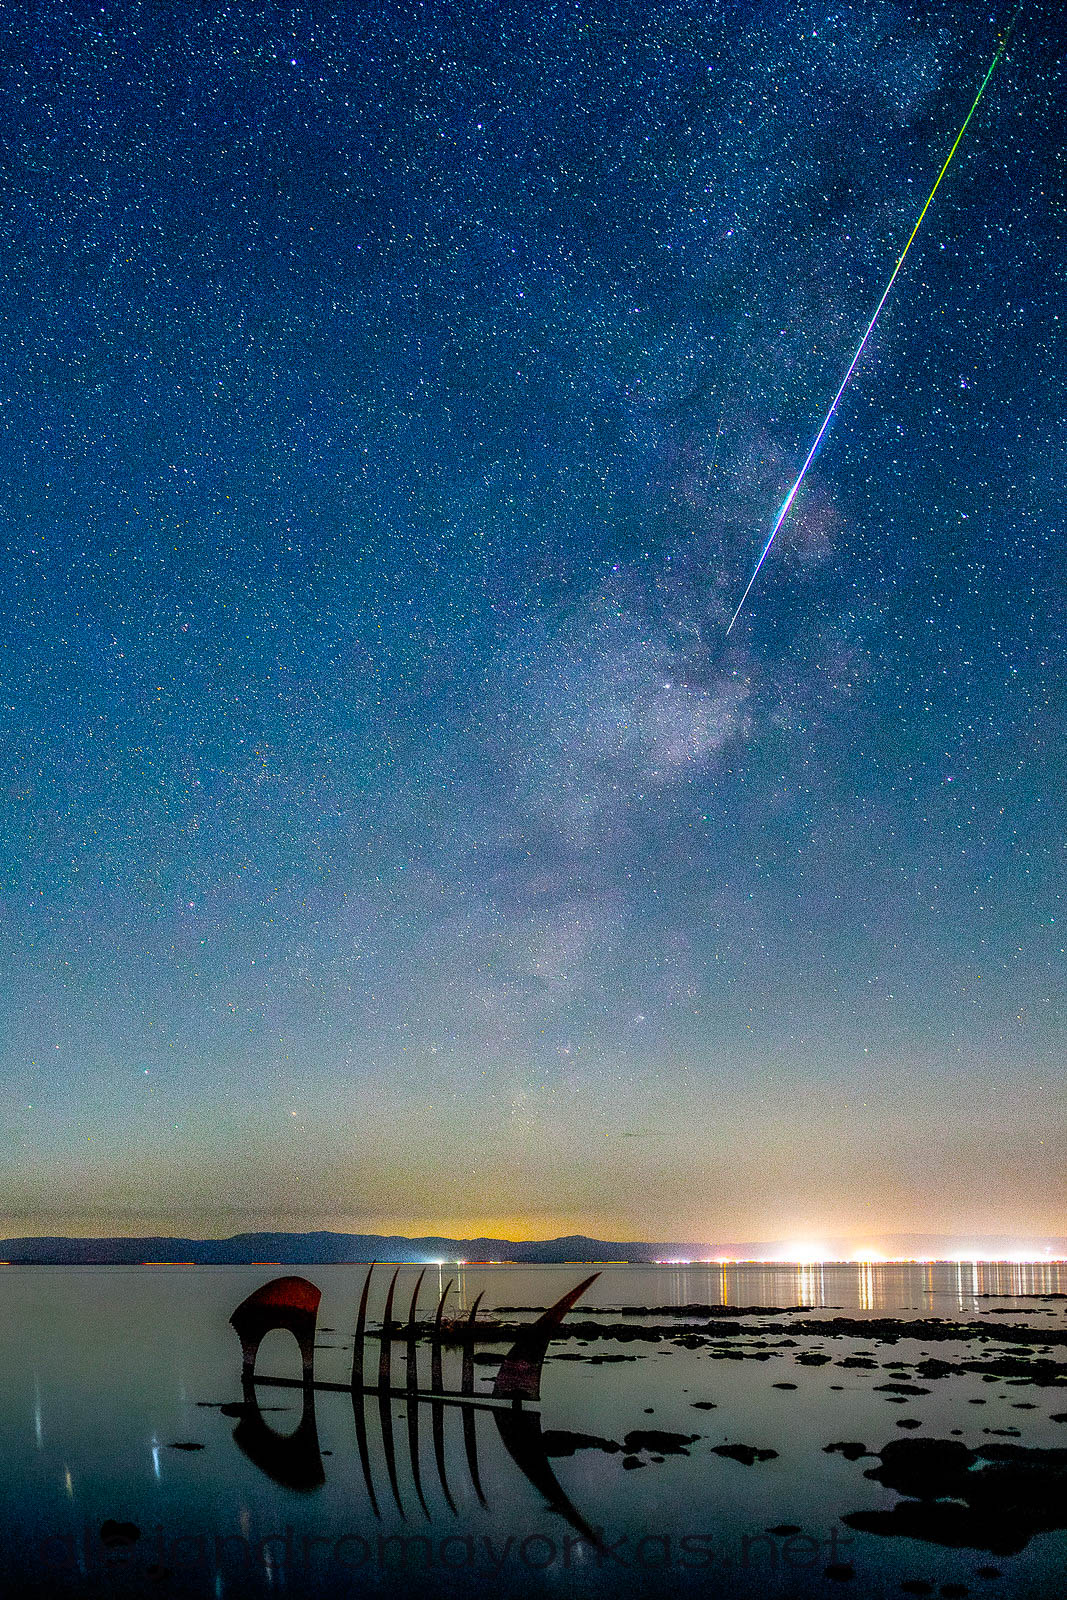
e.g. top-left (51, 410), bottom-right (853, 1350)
top-left (0, 0), bottom-right (1067, 1240)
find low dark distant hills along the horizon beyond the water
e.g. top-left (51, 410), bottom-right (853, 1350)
top-left (0, 1232), bottom-right (1067, 1267)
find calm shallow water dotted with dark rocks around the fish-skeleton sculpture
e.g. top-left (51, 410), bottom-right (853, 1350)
top-left (0, 1264), bottom-right (1067, 1597)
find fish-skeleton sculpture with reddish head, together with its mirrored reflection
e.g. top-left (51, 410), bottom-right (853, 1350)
top-left (227, 1262), bottom-right (600, 1542)
